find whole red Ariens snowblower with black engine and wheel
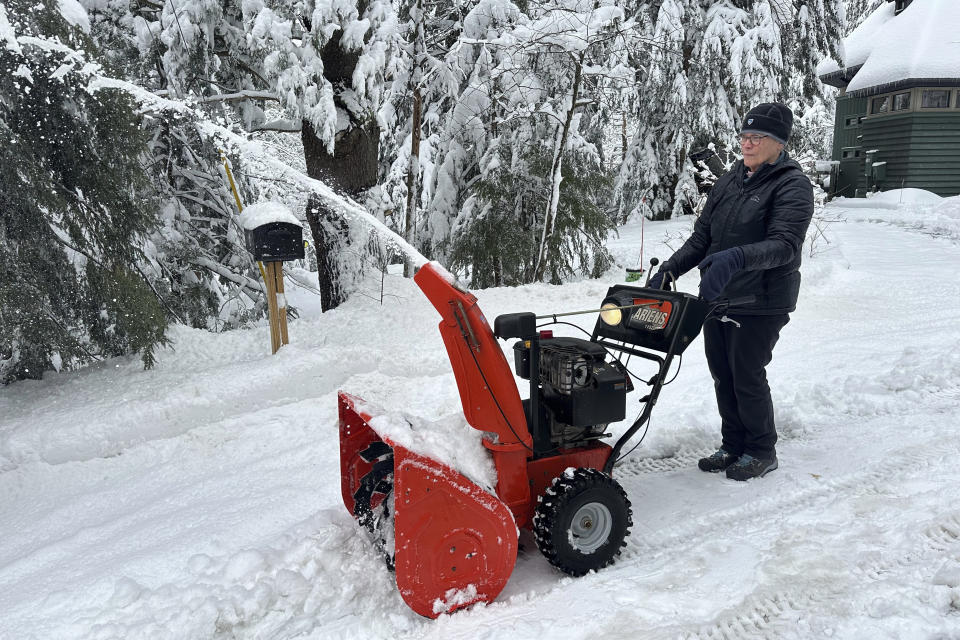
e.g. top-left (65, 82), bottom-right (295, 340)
top-left (339, 260), bottom-right (752, 618)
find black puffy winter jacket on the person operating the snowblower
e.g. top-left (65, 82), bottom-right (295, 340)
top-left (663, 153), bottom-right (813, 315)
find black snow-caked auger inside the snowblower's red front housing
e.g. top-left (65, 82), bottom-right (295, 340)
top-left (353, 442), bottom-right (394, 571)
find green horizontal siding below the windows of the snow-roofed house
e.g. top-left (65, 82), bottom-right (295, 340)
top-left (862, 110), bottom-right (960, 196)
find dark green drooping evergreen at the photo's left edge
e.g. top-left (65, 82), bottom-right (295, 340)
top-left (0, 0), bottom-right (168, 383)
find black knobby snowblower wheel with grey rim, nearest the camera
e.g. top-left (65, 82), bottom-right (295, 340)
top-left (533, 468), bottom-right (633, 576)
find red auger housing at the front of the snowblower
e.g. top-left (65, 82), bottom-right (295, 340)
top-left (339, 392), bottom-right (517, 618)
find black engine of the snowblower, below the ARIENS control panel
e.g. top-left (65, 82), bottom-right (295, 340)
top-left (513, 336), bottom-right (633, 449)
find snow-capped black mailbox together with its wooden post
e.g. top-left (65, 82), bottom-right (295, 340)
top-left (240, 201), bottom-right (304, 353)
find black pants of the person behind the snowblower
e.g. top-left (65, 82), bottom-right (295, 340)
top-left (703, 314), bottom-right (790, 460)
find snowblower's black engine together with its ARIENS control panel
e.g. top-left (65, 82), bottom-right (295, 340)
top-left (494, 285), bottom-right (707, 458)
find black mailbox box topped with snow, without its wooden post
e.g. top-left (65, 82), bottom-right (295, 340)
top-left (240, 202), bottom-right (304, 262)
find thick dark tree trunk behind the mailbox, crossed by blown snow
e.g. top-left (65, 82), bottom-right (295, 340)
top-left (301, 120), bottom-right (380, 311)
